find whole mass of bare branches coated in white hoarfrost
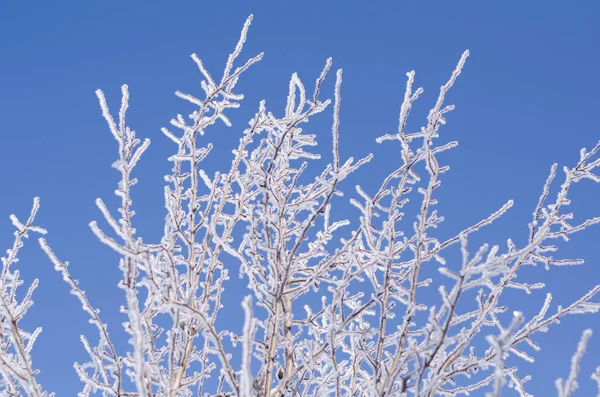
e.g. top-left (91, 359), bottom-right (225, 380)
top-left (0, 13), bottom-right (600, 397)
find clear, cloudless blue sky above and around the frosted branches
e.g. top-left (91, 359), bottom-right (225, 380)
top-left (0, 0), bottom-right (600, 396)
